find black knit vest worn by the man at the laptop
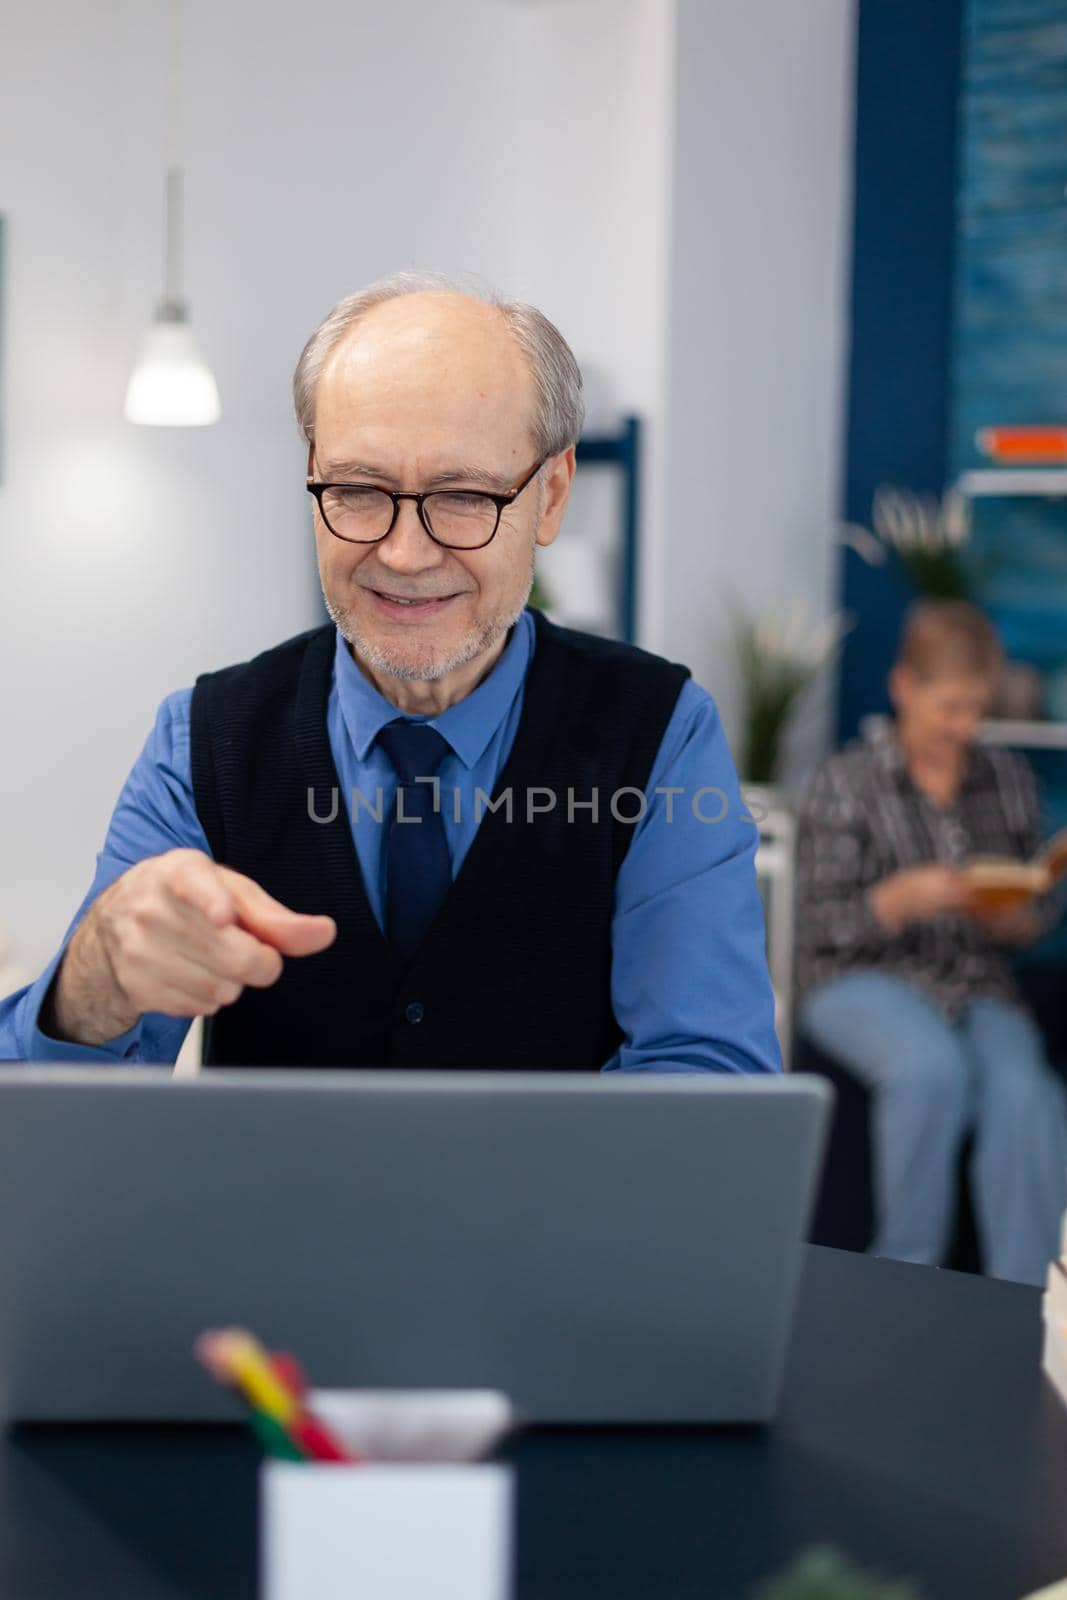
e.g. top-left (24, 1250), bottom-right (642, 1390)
top-left (190, 611), bottom-right (688, 1070)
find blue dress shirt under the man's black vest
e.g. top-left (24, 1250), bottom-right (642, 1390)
top-left (0, 613), bottom-right (781, 1072)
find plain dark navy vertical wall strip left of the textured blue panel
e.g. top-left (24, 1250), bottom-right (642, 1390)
top-left (838, 0), bottom-right (961, 739)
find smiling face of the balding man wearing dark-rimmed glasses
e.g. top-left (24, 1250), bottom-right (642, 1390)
top-left (314, 294), bottom-right (574, 691)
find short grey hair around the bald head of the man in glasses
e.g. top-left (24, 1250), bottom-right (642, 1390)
top-left (293, 272), bottom-right (584, 456)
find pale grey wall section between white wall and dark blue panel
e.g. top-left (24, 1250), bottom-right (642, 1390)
top-left (653, 0), bottom-right (854, 748)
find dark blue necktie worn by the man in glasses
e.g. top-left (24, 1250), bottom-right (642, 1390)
top-left (378, 722), bottom-right (453, 958)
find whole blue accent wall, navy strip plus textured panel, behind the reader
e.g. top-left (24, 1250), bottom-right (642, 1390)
top-left (838, 0), bottom-right (1067, 957)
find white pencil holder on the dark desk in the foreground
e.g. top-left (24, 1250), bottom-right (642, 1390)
top-left (261, 1390), bottom-right (514, 1600)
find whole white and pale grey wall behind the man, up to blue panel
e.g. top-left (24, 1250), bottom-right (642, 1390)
top-left (0, 0), bottom-right (851, 966)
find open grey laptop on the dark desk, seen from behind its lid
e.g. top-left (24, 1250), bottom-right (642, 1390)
top-left (0, 1067), bottom-right (832, 1424)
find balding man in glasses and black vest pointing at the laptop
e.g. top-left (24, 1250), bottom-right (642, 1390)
top-left (0, 274), bottom-right (779, 1072)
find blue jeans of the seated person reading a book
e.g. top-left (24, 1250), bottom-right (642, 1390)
top-left (798, 971), bottom-right (1067, 1283)
